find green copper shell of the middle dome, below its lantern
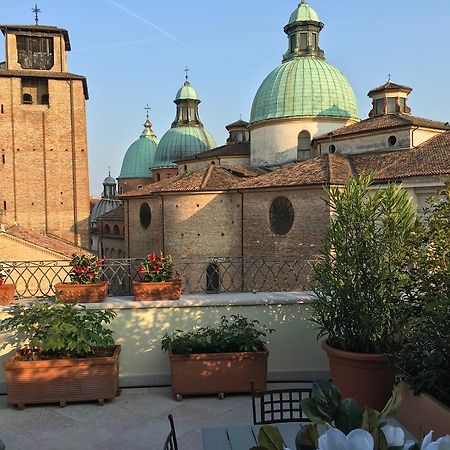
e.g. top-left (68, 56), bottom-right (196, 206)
top-left (153, 126), bottom-right (216, 168)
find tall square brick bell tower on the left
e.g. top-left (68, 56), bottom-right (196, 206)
top-left (0, 15), bottom-right (89, 248)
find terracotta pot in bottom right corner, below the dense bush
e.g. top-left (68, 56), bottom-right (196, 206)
top-left (395, 382), bottom-right (450, 440)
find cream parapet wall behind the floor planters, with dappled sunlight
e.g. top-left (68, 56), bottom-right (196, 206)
top-left (0, 292), bottom-right (329, 394)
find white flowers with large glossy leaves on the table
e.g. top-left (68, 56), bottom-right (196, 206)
top-left (250, 381), bottom-right (450, 450)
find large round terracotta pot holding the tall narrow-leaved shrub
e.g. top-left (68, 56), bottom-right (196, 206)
top-left (322, 341), bottom-right (394, 411)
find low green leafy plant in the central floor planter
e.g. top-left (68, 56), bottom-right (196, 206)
top-left (161, 315), bottom-right (275, 355)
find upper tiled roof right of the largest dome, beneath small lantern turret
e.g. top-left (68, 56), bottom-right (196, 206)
top-left (315, 114), bottom-right (450, 141)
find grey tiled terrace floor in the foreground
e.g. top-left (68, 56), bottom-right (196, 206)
top-left (0, 383), bottom-right (302, 450)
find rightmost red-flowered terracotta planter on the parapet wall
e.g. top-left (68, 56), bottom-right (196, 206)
top-left (133, 253), bottom-right (181, 301)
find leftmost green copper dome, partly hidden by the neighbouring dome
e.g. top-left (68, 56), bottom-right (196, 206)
top-left (118, 119), bottom-right (158, 179)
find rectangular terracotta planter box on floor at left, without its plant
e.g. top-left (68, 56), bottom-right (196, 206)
top-left (3, 345), bottom-right (121, 409)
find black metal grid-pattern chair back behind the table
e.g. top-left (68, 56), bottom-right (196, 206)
top-left (251, 381), bottom-right (312, 425)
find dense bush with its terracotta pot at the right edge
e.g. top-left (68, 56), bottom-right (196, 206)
top-left (394, 185), bottom-right (450, 437)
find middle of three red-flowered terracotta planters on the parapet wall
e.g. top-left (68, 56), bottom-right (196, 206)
top-left (55, 254), bottom-right (109, 303)
